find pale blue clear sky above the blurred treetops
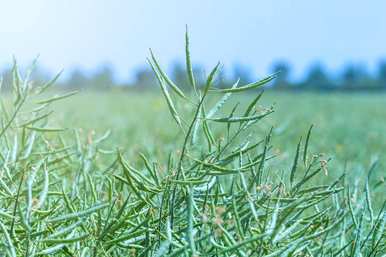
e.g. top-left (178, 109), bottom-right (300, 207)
top-left (0, 0), bottom-right (386, 80)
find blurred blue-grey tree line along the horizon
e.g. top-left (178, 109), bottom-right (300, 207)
top-left (0, 59), bottom-right (386, 91)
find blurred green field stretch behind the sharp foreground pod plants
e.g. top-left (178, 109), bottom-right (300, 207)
top-left (55, 91), bottom-right (386, 177)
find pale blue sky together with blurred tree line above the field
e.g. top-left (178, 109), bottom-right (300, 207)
top-left (0, 0), bottom-right (386, 92)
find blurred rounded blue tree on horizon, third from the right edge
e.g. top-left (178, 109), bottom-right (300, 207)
top-left (303, 63), bottom-right (333, 90)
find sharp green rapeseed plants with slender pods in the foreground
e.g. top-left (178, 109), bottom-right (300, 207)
top-left (0, 36), bottom-right (386, 256)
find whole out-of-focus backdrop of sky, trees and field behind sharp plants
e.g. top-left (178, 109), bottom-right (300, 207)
top-left (0, 0), bottom-right (386, 174)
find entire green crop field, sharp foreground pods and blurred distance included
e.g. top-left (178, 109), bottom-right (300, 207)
top-left (0, 40), bottom-right (386, 254)
